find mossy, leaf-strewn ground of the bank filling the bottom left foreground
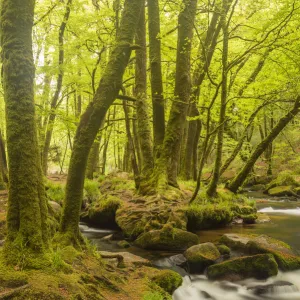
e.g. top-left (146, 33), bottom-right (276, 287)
top-left (0, 247), bottom-right (176, 300)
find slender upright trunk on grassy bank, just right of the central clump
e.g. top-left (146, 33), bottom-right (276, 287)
top-left (206, 0), bottom-right (228, 197)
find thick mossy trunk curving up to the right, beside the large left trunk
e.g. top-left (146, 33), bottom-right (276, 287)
top-left (60, 0), bottom-right (144, 245)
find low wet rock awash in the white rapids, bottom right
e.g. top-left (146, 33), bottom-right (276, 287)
top-left (248, 281), bottom-right (299, 296)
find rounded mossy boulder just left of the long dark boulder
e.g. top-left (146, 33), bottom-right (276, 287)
top-left (184, 243), bottom-right (221, 273)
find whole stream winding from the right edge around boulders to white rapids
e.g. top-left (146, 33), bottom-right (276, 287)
top-left (80, 193), bottom-right (300, 300)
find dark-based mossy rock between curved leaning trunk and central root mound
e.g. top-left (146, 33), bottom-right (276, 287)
top-left (82, 195), bottom-right (122, 228)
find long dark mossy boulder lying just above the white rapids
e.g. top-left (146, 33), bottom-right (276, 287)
top-left (207, 254), bottom-right (278, 281)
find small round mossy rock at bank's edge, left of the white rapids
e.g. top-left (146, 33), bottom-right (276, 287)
top-left (152, 270), bottom-right (182, 295)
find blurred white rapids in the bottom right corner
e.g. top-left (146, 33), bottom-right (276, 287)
top-left (173, 271), bottom-right (300, 300)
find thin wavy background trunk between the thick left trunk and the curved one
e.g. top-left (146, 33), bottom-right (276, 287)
top-left (42, 0), bottom-right (72, 175)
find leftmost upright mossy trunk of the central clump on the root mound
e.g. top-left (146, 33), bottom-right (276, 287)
top-left (135, 1), bottom-right (154, 183)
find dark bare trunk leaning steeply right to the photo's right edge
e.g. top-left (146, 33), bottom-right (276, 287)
top-left (227, 97), bottom-right (300, 193)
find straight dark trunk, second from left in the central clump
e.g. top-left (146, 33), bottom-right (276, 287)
top-left (148, 0), bottom-right (165, 156)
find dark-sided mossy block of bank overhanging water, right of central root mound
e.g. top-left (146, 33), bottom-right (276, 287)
top-left (186, 204), bottom-right (234, 231)
